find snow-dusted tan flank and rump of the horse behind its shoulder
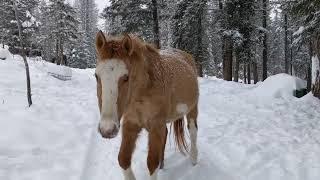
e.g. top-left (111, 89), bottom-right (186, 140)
top-left (160, 49), bottom-right (199, 121)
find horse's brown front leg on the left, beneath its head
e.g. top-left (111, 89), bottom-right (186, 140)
top-left (118, 122), bottom-right (141, 180)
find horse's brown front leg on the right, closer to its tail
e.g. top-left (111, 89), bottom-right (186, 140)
top-left (147, 125), bottom-right (166, 180)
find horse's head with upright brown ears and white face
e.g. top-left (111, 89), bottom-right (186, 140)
top-left (95, 31), bottom-right (133, 138)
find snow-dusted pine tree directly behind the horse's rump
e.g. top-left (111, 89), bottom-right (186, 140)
top-left (172, 0), bottom-right (208, 77)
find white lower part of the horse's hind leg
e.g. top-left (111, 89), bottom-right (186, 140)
top-left (189, 119), bottom-right (198, 165)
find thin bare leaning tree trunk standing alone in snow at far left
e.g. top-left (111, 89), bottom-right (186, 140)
top-left (12, 0), bottom-right (32, 107)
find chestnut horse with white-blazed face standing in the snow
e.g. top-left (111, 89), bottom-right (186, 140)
top-left (95, 31), bottom-right (199, 180)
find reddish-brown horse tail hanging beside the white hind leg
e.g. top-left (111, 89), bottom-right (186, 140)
top-left (173, 118), bottom-right (188, 154)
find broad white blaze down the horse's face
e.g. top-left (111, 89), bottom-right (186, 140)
top-left (96, 59), bottom-right (128, 131)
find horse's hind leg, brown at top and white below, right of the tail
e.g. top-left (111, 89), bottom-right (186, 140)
top-left (187, 106), bottom-right (198, 165)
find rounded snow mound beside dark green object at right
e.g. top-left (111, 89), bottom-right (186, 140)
top-left (250, 74), bottom-right (307, 98)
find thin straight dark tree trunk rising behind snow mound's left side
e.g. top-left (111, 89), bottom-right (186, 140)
top-left (262, 0), bottom-right (268, 81)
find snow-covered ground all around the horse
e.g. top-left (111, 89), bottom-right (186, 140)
top-left (0, 56), bottom-right (320, 180)
